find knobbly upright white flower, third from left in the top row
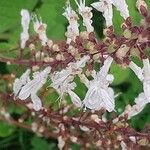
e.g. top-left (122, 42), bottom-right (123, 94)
top-left (63, 1), bottom-right (79, 43)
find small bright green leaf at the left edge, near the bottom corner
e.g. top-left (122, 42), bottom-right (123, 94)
top-left (0, 121), bottom-right (15, 137)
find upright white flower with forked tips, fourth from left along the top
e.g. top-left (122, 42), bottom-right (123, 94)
top-left (75, 0), bottom-right (94, 33)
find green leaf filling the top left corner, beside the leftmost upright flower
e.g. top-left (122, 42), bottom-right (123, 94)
top-left (0, 0), bottom-right (38, 33)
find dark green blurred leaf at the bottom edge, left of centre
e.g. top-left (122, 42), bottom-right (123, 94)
top-left (31, 136), bottom-right (57, 150)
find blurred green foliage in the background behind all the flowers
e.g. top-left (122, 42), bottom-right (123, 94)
top-left (0, 0), bottom-right (150, 150)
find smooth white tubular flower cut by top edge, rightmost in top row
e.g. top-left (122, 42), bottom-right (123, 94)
top-left (112, 0), bottom-right (129, 19)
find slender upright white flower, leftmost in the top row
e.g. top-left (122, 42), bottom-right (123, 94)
top-left (20, 9), bottom-right (30, 49)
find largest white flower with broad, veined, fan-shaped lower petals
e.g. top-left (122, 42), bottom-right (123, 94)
top-left (83, 57), bottom-right (115, 112)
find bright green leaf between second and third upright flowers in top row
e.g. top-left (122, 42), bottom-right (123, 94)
top-left (38, 0), bottom-right (67, 40)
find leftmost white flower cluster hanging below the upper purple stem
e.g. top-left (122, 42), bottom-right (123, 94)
top-left (13, 67), bottom-right (51, 111)
